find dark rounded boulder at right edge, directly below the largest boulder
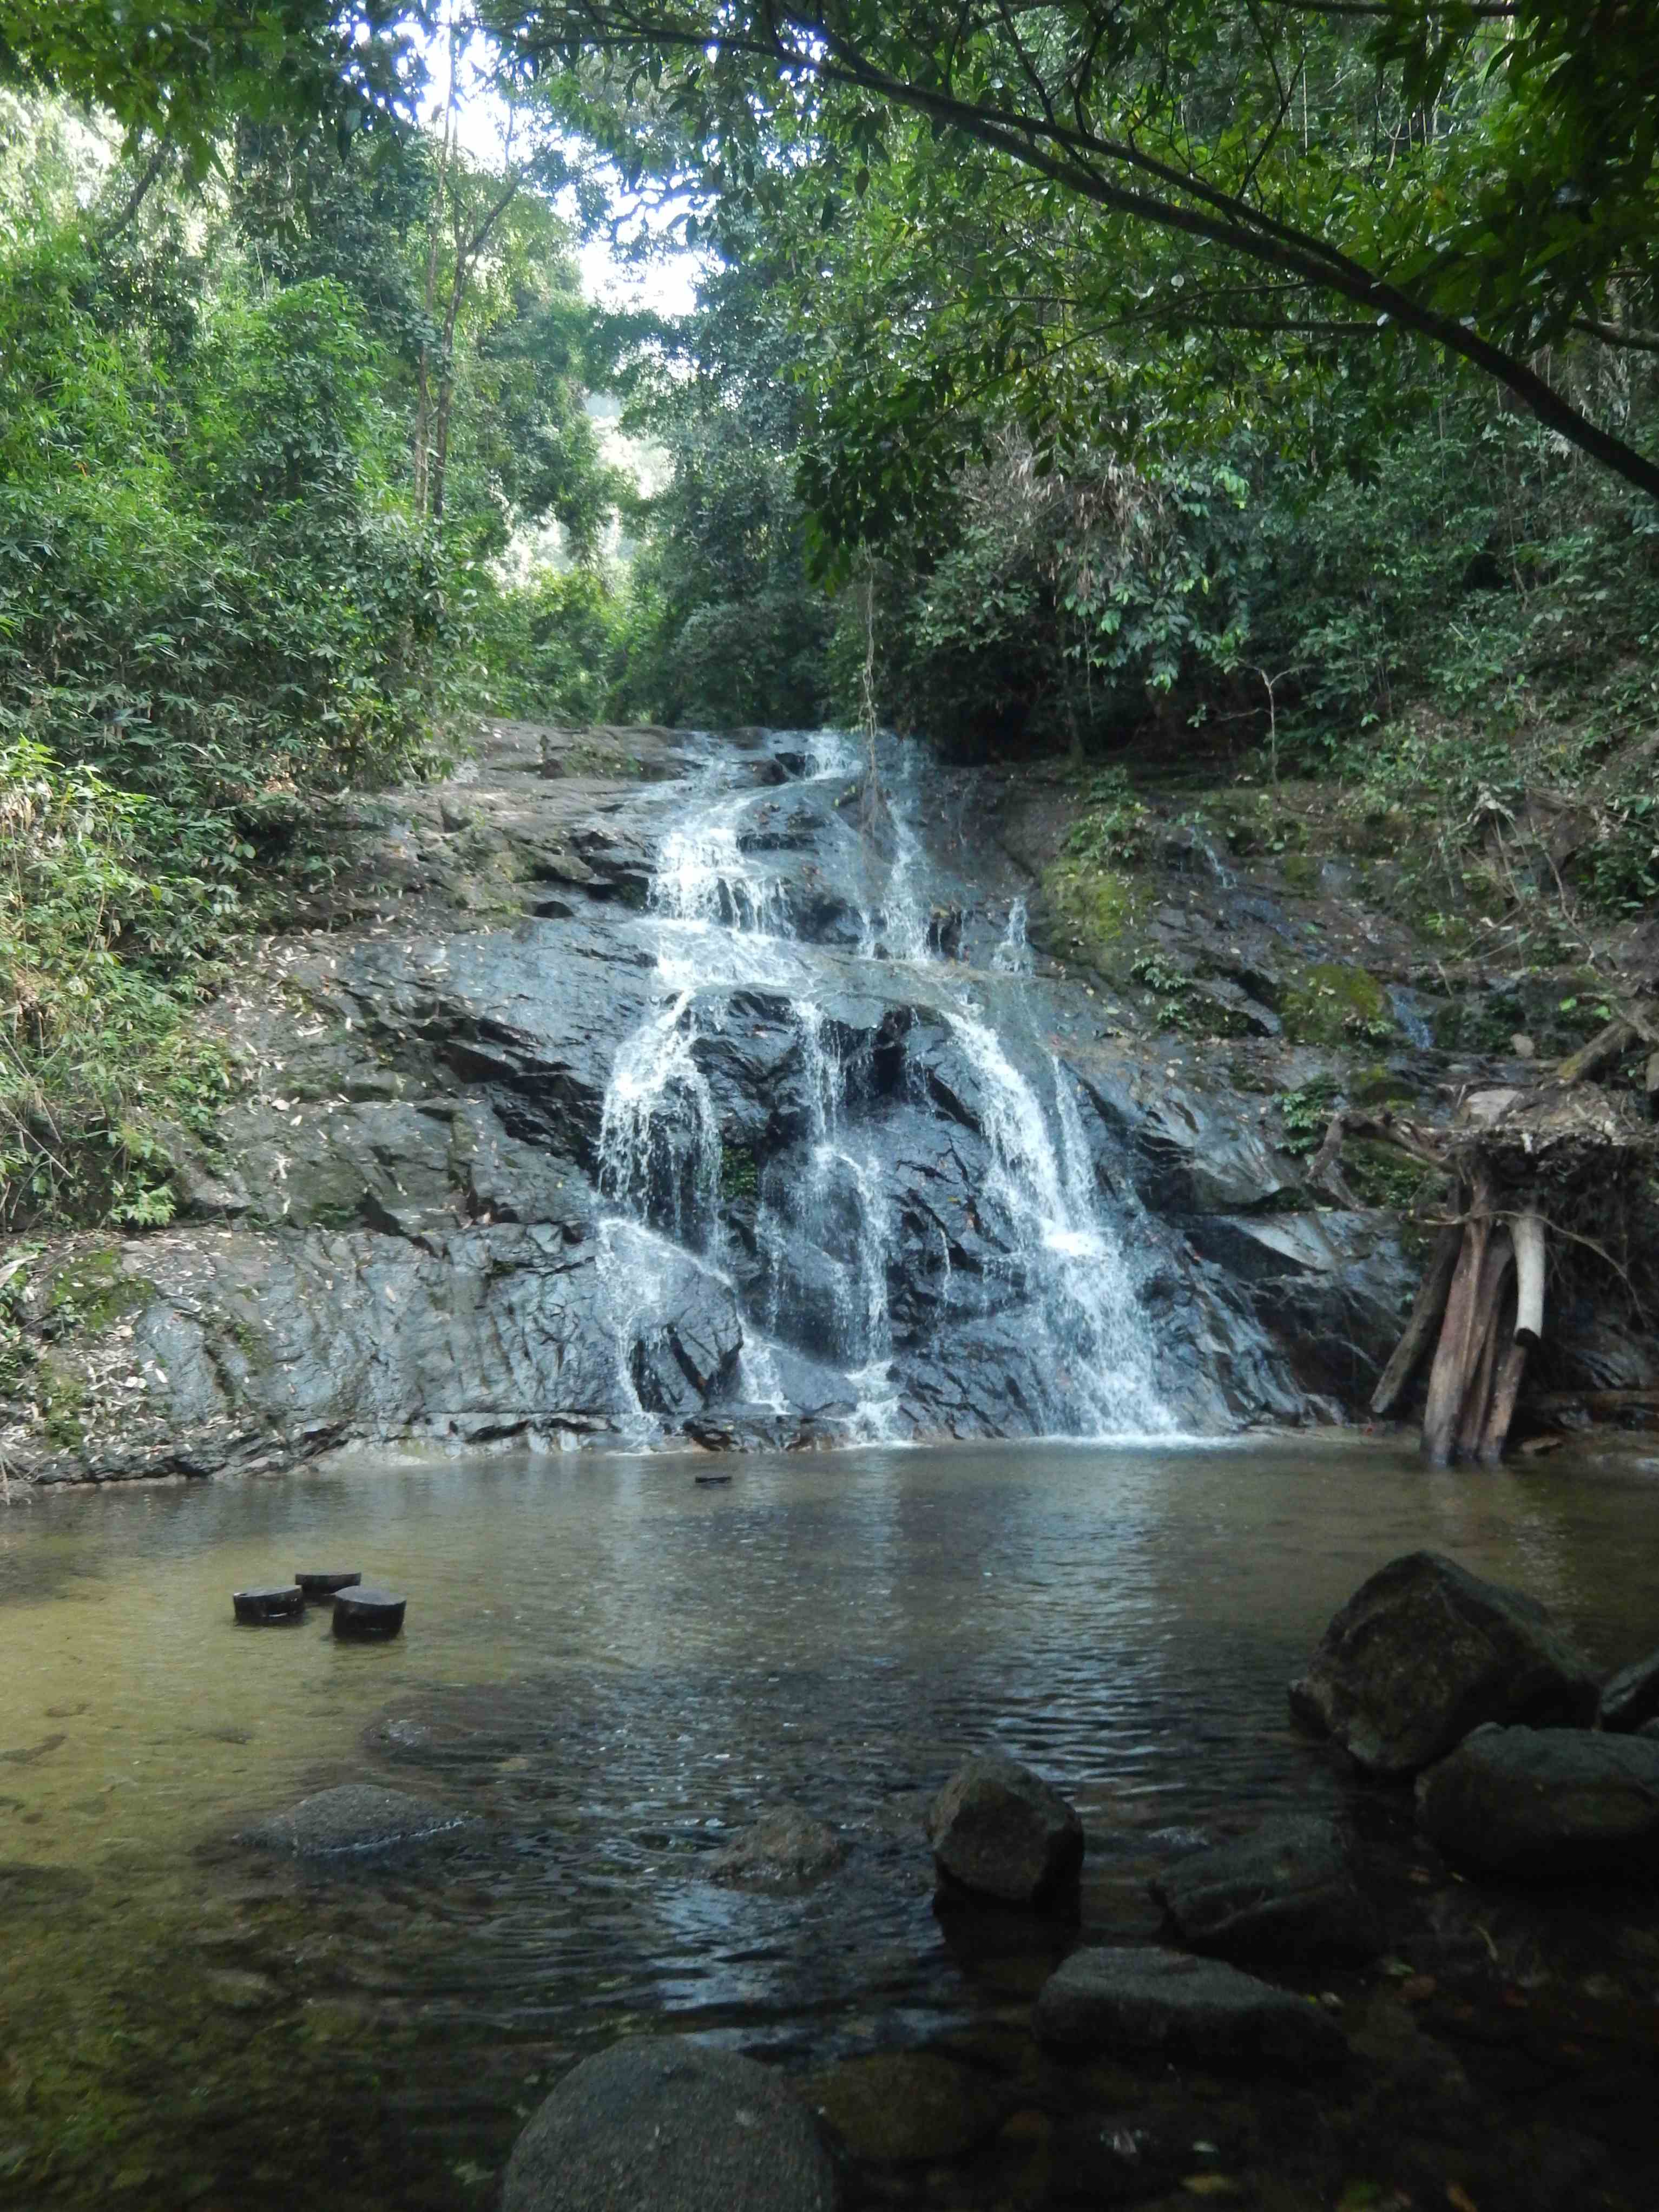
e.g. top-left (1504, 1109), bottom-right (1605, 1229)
top-left (1418, 1728), bottom-right (1659, 1880)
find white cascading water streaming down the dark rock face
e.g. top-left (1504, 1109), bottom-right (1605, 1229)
top-left (600, 732), bottom-right (1173, 1438)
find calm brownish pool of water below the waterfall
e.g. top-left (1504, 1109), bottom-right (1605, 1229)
top-left (0, 1440), bottom-right (1659, 2212)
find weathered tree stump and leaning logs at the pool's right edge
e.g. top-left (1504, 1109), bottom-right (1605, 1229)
top-left (1312, 1048), bottom-right (1659, 1466)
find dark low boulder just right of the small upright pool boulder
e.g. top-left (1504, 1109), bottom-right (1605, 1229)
top-left (1150, 1816), bottom-right (1385, 1960)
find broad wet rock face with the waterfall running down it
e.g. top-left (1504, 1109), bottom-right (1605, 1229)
top-left (0, 723), bottom-right (1423, 1482)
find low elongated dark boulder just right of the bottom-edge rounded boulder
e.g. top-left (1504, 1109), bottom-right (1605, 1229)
top-left (1033, 1946), bottom-right (1347, 2068)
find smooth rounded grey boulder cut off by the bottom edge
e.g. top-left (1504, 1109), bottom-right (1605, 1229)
top-left (502, 2035), bottom-right (836, 2212)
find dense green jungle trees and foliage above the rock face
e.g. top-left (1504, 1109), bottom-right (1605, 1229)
top-left (0, 0), bottom-right (1659, 1221)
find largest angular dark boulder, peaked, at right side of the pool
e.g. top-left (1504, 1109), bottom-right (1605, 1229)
top-left (1289, 1551), bottom-right (1597, 1781)
